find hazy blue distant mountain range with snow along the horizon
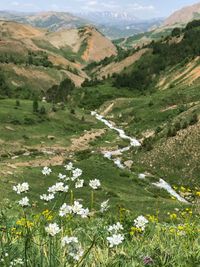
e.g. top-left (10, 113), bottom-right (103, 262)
top-left (0, 11), bottom-right (162, 39)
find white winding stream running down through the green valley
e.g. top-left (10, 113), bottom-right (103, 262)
top-left (91, 111), bottom-right (188, 203)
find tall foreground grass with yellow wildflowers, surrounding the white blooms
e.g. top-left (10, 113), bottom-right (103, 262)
top-left (0, 163), bottom-right (200, 267)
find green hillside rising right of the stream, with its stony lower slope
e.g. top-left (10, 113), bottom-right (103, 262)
top-left (81, 83), bottom-right (200, 187)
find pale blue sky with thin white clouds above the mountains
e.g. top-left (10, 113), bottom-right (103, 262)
top-left (0, 0), bottom-right (200, 18)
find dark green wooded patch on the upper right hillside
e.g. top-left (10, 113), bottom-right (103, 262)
top-left (114, 21), bottom-right (200, 91)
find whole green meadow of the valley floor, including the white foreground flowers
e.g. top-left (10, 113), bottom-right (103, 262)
top-left (0, 80), bottom-right (200, 267)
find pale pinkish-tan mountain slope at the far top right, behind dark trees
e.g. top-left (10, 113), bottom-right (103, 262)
top-left (164, 3), bottom-right (200, 26)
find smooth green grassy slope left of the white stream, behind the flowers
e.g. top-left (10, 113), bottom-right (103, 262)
top-left (0, 96), bottom-right (189, 218)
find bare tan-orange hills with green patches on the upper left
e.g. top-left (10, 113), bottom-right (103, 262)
top-left (0, 21), bottom-right (117, 91)
